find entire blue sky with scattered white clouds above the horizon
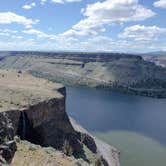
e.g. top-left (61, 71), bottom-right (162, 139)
top-left (0, 0), bottom-right (166, 52)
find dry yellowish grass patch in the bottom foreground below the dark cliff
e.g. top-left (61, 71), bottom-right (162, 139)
top-left (11, 142), bottom-right (75, 166)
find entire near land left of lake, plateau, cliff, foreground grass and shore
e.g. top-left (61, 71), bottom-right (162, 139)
top-left (0, 70), bottom-right (120, 166)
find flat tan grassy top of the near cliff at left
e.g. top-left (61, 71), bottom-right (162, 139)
top-left (0, 70), bottom-right (63, 112)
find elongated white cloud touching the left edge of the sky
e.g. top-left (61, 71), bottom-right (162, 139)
top-left (0, 12), bottom-right (39, 28)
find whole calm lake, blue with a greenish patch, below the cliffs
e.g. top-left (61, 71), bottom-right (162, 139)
top-left (66, 87), bottom-right (166, 166)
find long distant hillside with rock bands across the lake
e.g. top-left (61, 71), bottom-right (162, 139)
top-left (0, 52), bottom-right (166, 97)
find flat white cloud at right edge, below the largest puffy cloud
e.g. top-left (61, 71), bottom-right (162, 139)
top-left (119, 25), bottom-right (166, 42)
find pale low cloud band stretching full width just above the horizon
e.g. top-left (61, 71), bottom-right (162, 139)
top-left (0, 33), bottom-right (166, 52)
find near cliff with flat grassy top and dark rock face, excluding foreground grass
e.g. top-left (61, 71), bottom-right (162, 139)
top-left (0, 70), bottom-right (118, 165)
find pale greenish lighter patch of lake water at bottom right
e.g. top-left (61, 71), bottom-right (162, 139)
top-left (93, 131), bottom-right (166, 166)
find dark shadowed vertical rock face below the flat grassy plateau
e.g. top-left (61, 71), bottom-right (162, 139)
top-left (6, 98), bottom-right (86, 157)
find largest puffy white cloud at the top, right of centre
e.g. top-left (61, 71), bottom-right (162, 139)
top-left (82, 0), bottom-right (154, 22)
